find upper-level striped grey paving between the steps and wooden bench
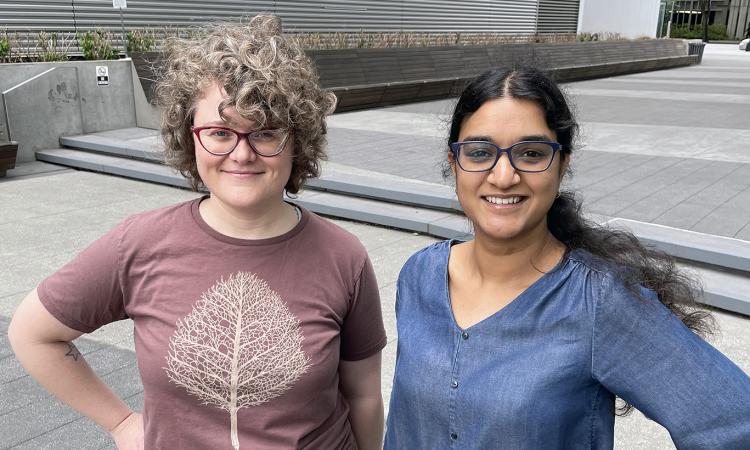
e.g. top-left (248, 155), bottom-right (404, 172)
top-left (329, 44), bottom-right (750, 240)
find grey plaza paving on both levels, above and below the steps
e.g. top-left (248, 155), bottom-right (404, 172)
top-left (0, 45), bottom-right (750, 450)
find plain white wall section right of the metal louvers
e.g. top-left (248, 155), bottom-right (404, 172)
top-left (578, 0), bottom-right (660, 39)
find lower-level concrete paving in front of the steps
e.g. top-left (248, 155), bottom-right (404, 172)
top-left (0, 166), bottom-right (750, 450)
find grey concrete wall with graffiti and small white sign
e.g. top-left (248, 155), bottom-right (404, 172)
top-left (0, 60), bottom-right (136, 162)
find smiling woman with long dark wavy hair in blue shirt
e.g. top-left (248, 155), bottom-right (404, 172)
top-left (385, 65), bottom-right (750, 450)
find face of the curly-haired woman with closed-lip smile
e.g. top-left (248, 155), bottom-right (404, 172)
top-left (193, 83), bottom-right (294, 214)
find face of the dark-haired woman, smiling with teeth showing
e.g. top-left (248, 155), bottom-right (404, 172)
top-left (449, 97), bottom-right (567, 244)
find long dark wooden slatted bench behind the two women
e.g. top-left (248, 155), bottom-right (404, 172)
top-left (132, 39), bottom-right (699, 111)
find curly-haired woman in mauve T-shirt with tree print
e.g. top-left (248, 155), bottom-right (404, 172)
top-left (9, 16), bottom-right (386, 450)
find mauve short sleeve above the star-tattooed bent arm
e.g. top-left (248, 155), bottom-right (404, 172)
top-left (37, 221), bottom-right (127, 333)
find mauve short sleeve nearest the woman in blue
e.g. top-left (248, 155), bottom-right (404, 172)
top-left (340, 257), bottom-right (386, 361)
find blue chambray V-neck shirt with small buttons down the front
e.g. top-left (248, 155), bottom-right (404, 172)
top-left (385, 241), bottom-right (750, 450)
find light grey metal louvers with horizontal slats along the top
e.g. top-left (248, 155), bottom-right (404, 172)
top-left (0, 0), bottom-right (548, 33)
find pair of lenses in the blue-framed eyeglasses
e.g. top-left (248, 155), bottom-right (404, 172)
top-left (458, 142), bottom-right (555, 172)
